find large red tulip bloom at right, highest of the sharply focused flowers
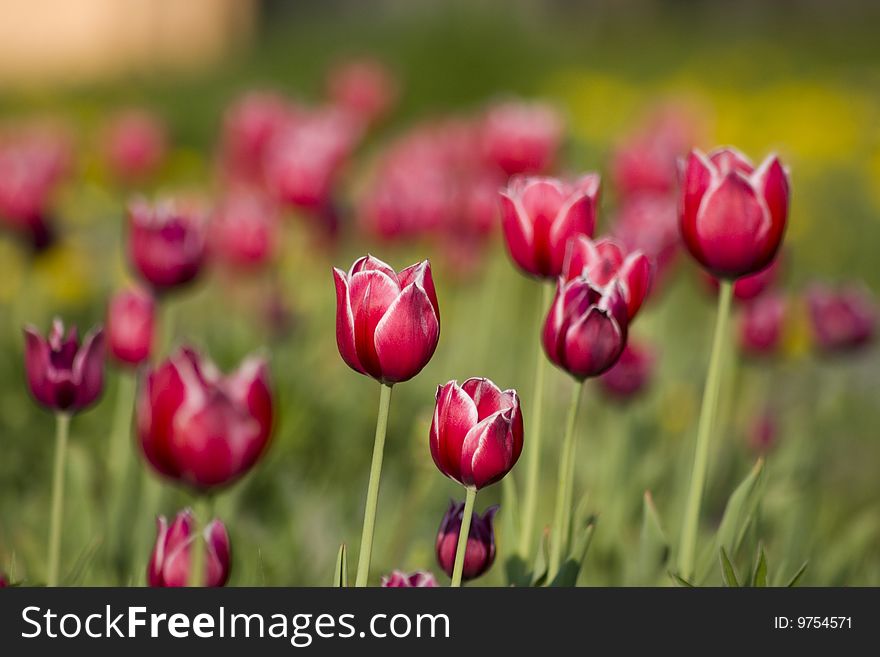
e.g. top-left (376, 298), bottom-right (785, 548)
top-left (680, 148), bottom-right (789, 279)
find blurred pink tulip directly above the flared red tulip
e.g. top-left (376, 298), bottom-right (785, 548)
top-left (483, 101), bottom-right (563, 175)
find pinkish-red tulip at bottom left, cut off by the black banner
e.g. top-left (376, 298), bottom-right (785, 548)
top-left (147, 509), bottom-right (231, 587)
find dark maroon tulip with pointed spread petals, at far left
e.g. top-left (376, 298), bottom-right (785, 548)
top-left (24, 319), bottom-right (104, 413)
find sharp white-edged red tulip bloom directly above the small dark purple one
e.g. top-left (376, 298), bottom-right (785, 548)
top-left (430, 378), bottom-right (523, 490)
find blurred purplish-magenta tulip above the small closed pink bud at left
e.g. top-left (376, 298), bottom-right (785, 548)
top-left (128, 200), bottom-right (206, 293)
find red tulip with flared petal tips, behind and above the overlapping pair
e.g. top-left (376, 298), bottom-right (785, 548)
top-left (501, 174), bottom-right (599, 278)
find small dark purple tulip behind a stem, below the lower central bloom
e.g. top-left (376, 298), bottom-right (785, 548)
top-left (435, 500), bottom-right (498, 580)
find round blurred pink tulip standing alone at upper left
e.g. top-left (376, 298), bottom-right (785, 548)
top-left (104, 110), bottom-right (168, 181)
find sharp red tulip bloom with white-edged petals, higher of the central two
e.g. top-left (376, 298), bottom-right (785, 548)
top-left (333, 255), bottom-right (440, 384)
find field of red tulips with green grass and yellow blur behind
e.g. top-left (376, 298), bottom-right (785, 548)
top-left (0, 2), bottom-right (880, 587)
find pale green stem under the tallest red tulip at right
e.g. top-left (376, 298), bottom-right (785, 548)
top-left (678, 281), bottom-right (733, 580)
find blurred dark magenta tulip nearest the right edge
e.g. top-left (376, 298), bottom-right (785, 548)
top-left (806, 284), bottom-right (877, 353)
